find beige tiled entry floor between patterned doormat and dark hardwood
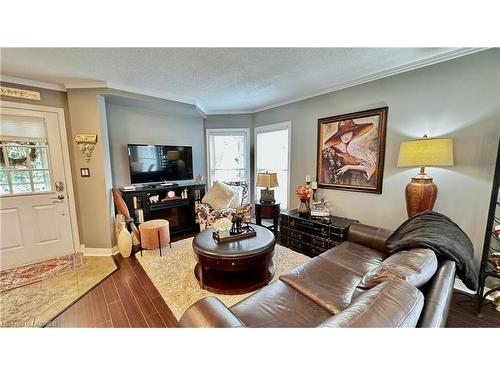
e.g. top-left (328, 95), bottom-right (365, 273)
top-left (0, 256), bottom-right (117, 327)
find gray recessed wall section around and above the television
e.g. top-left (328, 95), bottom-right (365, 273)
top-left (106, 101), bottom-right (206, 187)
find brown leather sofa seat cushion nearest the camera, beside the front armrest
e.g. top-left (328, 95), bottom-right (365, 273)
top-left (230, 280), bottom-right (332, 328)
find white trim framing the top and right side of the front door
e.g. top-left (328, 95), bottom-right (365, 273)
top-left (0, 100), bottom-right (80, 253)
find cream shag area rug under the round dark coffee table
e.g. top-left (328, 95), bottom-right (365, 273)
top-left (135, 238), bottom-right (309, 320)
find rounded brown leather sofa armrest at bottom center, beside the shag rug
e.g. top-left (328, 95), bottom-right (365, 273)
top-left (179, 297), bottom-right (245, 328)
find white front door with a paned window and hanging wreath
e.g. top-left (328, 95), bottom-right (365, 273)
top-left (0, 102), bottom-right (76, 270)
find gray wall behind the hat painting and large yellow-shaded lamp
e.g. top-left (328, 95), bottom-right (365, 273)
top-left (253, 49), bottom-right (500, 259)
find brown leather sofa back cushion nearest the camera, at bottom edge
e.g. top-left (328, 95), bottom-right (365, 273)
top-left (320, 279), bottom-right (424, 328)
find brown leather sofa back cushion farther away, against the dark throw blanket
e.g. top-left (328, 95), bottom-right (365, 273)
top-left (359, 249), bottom-right (437, 289)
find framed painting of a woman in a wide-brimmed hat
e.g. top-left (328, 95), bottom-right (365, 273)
top-left (316, 107), bottom-right (389, 194)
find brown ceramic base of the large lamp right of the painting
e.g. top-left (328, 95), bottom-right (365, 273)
top-left (405, 174), bottom-right (437, 217)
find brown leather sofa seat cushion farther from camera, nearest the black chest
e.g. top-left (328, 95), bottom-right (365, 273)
top-left (279, 257), bottom-right (363, 314)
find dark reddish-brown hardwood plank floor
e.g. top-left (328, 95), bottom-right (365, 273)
top-left (48, 236), bottom-right (500, 328)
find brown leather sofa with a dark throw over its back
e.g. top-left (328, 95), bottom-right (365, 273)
top-left (180, 224), bottom-right (455, 327)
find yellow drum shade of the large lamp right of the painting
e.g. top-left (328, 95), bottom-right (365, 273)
top-left (398, 136), bottom-right (453, 167)
